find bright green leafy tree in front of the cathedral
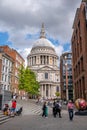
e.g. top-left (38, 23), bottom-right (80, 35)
top-left (19, 66), bottom-right (40, 95)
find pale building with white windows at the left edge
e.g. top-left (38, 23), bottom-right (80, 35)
top-left (0, 52), bottom-right (14, 108)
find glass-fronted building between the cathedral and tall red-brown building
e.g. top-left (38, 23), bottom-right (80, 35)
top-left (60, 52), bottom-right (73, 100)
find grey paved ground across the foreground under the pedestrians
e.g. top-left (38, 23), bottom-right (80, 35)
top-left (0, 99), bottom-right (87, 130)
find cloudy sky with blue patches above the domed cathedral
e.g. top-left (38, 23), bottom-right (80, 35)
top-left (0, 0), bottom-right (82, 65)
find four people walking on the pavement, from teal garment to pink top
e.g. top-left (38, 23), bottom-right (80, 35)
top-left (42, 100), bottom-right (74, 121)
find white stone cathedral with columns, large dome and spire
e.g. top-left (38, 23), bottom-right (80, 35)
top-left (27, 24), bottom-right (60, 98)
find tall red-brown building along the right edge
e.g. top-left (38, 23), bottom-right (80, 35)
top-left (71, 0), bottom-right (87, 100)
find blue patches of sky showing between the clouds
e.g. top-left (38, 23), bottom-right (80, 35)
top-left (0, 32), bottom-right (71, 51)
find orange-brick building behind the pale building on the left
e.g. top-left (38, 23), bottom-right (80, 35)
top-left (0, 46), bottom-right (24, 94)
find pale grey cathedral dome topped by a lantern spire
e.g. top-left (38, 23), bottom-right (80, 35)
top-left (30, 24), bottom-right (56, 55)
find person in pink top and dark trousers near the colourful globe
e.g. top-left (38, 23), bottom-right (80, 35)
top-left (67, 100), bottom-right (74, 121)
